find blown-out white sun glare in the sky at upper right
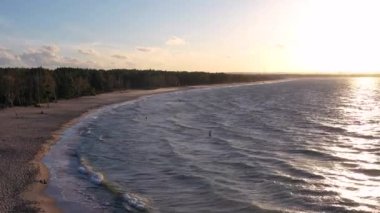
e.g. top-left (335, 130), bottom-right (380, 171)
top-left (291, 0), bottom-right (380, 73)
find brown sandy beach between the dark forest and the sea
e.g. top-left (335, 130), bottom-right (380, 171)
top-left (0, 88), bottom-right (178, 212)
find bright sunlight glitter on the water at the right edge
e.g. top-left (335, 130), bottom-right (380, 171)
top-left (326, 78), bottom-right (380, 211)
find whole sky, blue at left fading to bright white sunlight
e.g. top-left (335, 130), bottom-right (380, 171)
top-left (0, 0), bottom-right (380, 73)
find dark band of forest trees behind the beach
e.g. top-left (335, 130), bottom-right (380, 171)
top-left (0, 67), bottom-right (282, 108)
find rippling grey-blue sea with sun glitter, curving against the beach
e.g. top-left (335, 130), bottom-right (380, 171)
top-left (44, 77), bottom-right (380, 213)
